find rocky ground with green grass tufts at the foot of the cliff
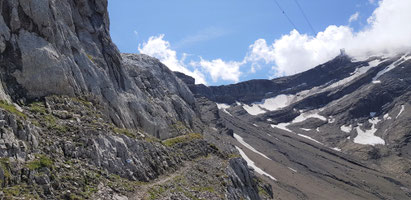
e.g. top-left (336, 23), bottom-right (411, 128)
top-left (0, 96), bottom-right (271, 199)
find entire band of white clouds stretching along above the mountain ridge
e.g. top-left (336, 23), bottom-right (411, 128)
top-left (138, 0), bottom-right (411, 84)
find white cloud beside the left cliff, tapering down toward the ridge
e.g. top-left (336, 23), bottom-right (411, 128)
top-left (138, 35), bottom-right (207, 84)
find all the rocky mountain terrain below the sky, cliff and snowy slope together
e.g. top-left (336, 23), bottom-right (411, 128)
top-left (0, 0), bottom-right (411, 200)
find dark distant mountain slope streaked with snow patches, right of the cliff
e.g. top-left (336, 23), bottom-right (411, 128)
top-left (178, 54), bottom-right (411, 199)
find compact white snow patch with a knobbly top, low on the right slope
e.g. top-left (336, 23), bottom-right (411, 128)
top-left (354, 118), bottom-right (385, 146)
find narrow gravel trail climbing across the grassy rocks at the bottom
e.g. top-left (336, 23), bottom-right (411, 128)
top-left (129, 162), bottom-right (192, 200)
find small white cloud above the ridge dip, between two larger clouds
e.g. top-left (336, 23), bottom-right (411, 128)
top-left (190, 58), bottom-right (244, 82)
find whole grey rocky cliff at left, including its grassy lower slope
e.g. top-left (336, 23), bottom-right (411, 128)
top-left (0, 0), bottom-right (272, 199)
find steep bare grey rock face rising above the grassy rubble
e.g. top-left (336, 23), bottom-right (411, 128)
top-left (0, 0), bottom-right (200, 138)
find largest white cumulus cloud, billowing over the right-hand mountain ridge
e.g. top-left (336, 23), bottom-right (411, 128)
top-left (246, 0), bottom-right (411, 76)
